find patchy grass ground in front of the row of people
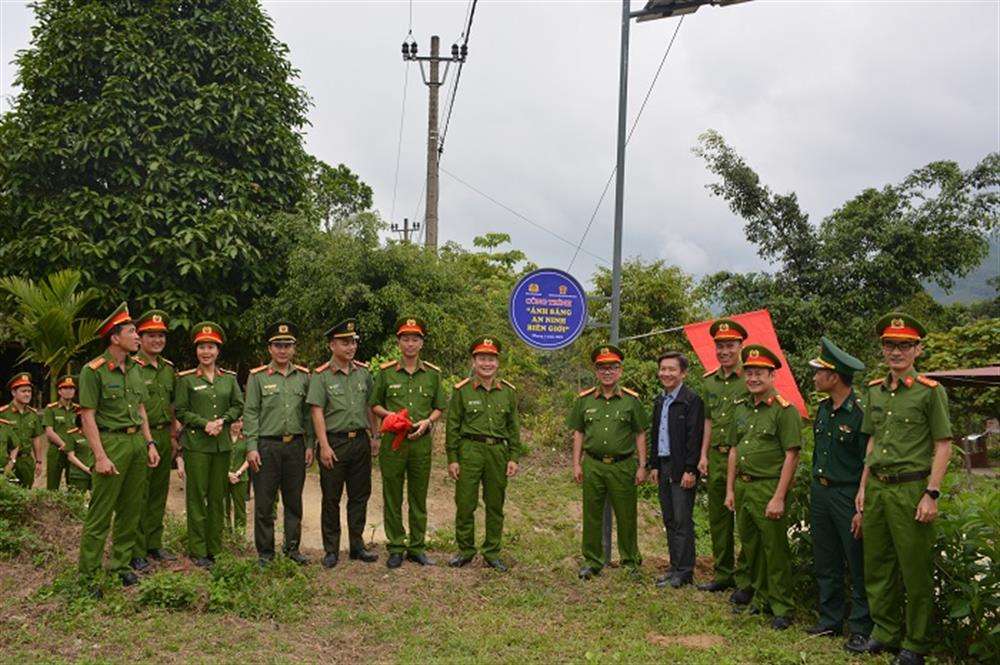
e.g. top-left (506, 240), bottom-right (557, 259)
top-left (0, 452), bottom-right (908, 665)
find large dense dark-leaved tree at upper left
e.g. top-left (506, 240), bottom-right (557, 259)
top-left (0, 0), bottom-right (313, 350)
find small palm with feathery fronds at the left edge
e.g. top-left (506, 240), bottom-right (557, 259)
top-left (0, 270), bottom-right (101, 400)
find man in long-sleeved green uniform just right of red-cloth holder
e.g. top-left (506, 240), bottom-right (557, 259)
top-left (445, 337), bottom-right (523, 573)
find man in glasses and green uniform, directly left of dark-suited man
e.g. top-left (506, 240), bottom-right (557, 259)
top-left (566, 344), bottom-right (649, 580)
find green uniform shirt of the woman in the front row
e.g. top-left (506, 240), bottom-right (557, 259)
top-left (174, 367), bottom-right (243, 453)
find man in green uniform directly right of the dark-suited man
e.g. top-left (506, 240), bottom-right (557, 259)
top-left (698, 319), bottom-right (753, 605)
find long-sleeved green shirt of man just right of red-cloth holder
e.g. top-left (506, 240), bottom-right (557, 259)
top-left (445, 379), bottom-right (524, 464)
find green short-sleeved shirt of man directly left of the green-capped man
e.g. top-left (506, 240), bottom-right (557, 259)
top-left (729, 389), bottom-right (802, 478)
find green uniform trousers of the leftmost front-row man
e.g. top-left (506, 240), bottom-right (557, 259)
top-left (80, 432), bottom-right (147, 578)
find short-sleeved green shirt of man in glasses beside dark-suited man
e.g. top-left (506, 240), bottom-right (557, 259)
top-left (566, 388), bottom-right (649, 457)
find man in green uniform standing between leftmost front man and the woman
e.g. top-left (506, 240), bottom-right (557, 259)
top-left (131, 309), bottom-right (180, 571)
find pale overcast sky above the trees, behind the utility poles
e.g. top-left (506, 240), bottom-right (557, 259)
top-left (0, 0), bottom-right (1000, 282)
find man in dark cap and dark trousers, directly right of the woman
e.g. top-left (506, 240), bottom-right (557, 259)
top-left (243, 320), bottom-right (314, 565)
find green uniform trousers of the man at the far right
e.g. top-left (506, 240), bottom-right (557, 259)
top-left (864, 475), bottom-right (934, 654)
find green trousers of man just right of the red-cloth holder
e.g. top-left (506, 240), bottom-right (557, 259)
top-left (455, 439), bottom-right (510, 561)
